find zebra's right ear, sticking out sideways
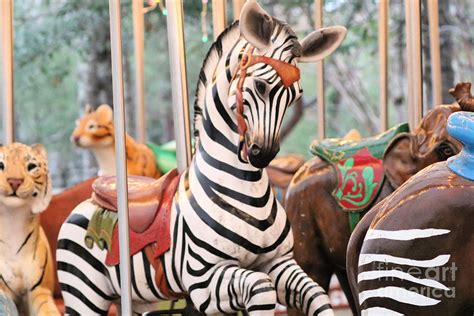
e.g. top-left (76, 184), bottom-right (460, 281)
top-left (299, 26), bottom-right (347, 63)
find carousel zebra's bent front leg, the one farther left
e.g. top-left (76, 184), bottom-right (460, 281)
top-left (189, 265), bottom-right (276, 315)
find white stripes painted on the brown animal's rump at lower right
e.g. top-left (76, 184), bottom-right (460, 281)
top-left (357, 228), bottom-right (452, 315)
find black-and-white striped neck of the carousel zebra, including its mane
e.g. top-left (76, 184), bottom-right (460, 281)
top-left (189, 24), bottom-right (272, 198)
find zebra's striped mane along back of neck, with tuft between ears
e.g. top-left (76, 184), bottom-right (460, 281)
top-left (194, 17), bottom-right (301, 145)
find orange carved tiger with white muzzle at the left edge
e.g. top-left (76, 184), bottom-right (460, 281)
top-left (0, 143), bottom-right (60, 315)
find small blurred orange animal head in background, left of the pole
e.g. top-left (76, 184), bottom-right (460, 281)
top-left (71, 104), bottom-right (114, 148)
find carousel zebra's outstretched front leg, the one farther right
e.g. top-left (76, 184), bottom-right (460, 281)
top-left (263, 253), bottom-right (334, 316)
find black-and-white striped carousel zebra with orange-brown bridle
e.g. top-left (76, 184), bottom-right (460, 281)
top-left (57, 1), bottom-right (346, 315)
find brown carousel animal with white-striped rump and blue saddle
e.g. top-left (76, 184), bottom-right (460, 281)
top-left (347, 83), bottom-right (474, 316)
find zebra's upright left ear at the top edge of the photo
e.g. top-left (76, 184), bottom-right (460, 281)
top-left (239, 1), bottom-right (273, 51)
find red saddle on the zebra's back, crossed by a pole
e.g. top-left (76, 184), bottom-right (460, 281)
top-left (92, 169), bottom-right (179, 265)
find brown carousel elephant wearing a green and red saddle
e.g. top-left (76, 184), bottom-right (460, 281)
top-left (285, 92), bottom-right (468, 310)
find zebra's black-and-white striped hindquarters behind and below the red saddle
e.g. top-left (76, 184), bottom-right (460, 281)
top-left (56, 201), bottom-right (165, 315)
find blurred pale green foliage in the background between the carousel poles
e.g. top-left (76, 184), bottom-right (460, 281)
top-left (4, 0), bottom-right (474, 187)
